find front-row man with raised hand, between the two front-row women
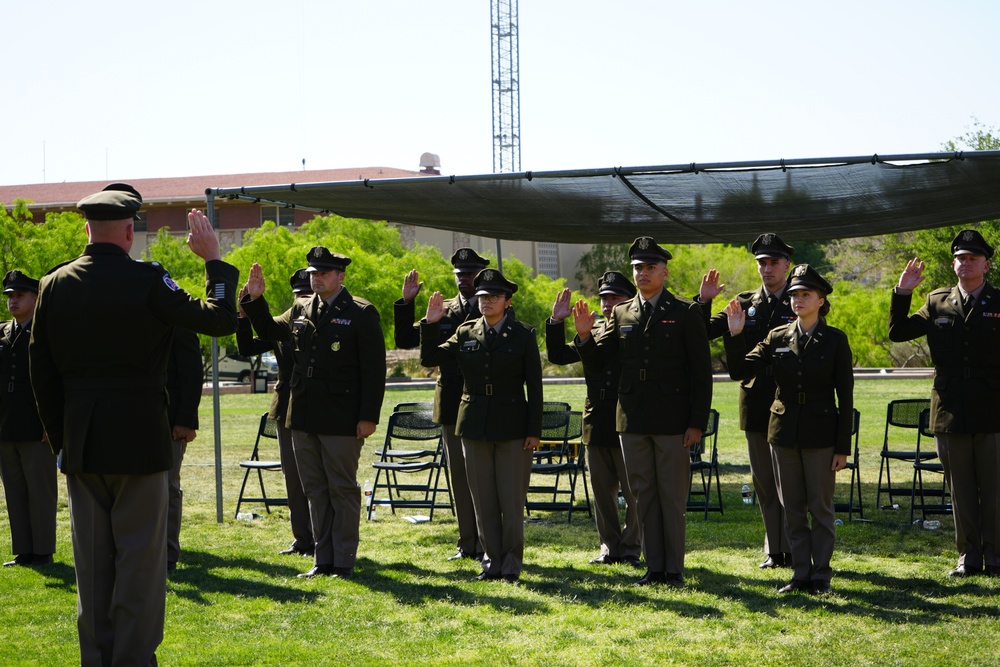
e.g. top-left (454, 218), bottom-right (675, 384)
top-left (573, 236), bottom-right (712, 586)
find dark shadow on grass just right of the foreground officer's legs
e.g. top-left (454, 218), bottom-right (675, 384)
top-left (167, 549), bottom-right (324, 605)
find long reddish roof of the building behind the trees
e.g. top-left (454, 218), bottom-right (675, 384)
top-left (0, 167), bottom-right (420, 208)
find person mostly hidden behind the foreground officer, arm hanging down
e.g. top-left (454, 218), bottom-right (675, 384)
top-left (167, 328), bottom-right (205, 573)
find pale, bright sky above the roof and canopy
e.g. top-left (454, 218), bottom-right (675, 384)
top-left (0, 0), bottom-right (1000, 185)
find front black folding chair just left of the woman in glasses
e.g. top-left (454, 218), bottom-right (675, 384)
top-left (368, 410), bottom-right (454, 520)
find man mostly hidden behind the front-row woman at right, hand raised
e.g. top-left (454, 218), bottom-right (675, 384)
top-left (699, 234), bottom-right (795, 568)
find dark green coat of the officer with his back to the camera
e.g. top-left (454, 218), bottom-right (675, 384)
top-left (30, 243), bottom-right (239, 475)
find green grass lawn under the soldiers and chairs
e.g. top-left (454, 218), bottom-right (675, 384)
top-left (0, 379), bottom-right (1000, 667)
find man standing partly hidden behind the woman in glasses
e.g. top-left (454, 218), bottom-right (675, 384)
top-left (393, 248), bottom-right (490, 561)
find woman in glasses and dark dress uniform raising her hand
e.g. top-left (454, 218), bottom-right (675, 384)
top-left (420, 269), bottom-right (542, 582)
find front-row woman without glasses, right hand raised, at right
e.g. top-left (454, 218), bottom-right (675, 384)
top-left (724, 264), bottom-right (854, 594)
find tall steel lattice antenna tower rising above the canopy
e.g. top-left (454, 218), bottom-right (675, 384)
top-left (490, 0), bottom-right (521, 173)
